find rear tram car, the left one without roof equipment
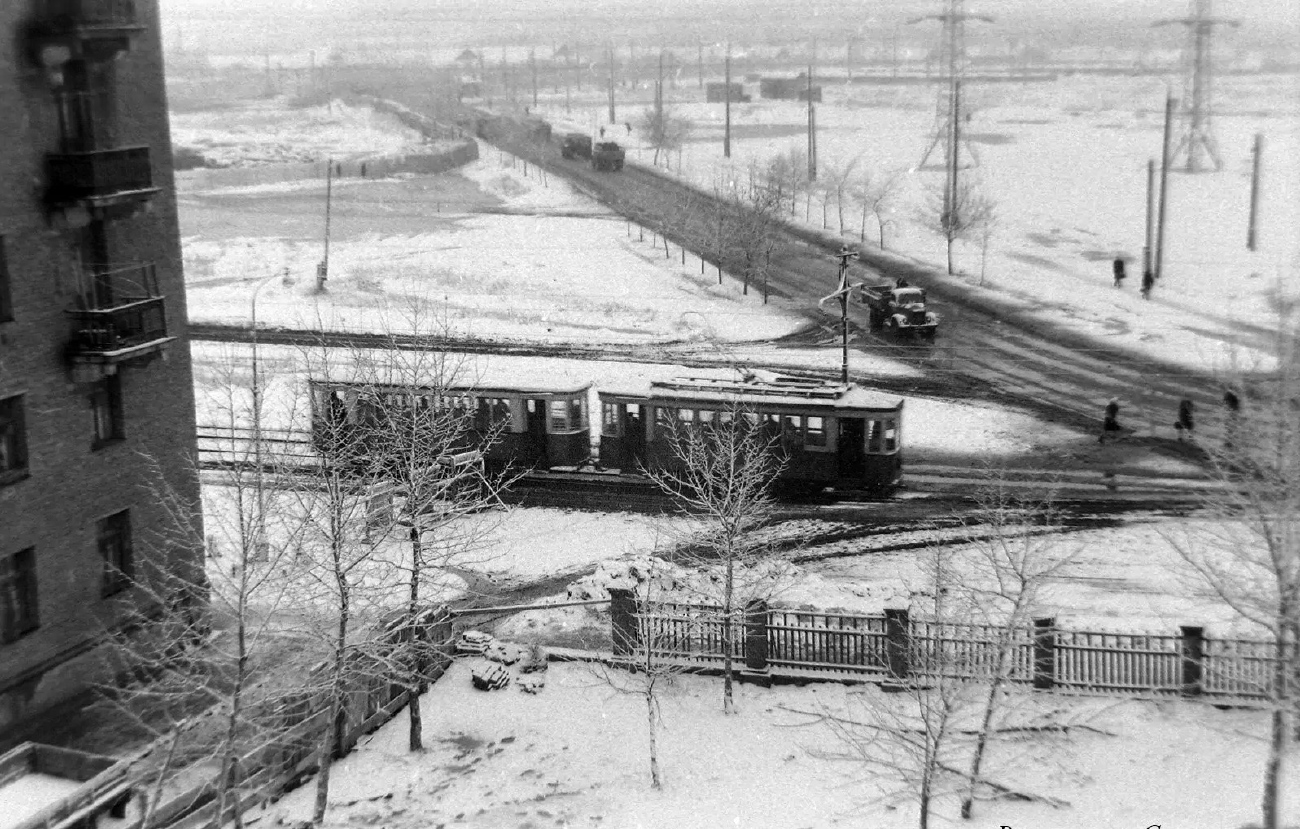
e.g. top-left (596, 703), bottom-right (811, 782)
top-left (311, 381), bottom-right (592, 472)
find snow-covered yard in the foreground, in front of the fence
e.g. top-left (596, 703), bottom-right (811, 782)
top-left (248, 660), bottom-right (1300, 829)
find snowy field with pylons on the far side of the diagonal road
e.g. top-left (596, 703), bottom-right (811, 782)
top-left (538, 75), bottom-right (1300, 376)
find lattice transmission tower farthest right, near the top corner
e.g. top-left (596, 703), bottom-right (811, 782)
top-left (1152, 0), bottom-right (1240, 173)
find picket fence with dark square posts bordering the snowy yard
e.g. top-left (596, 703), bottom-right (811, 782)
top-left (610, 590), bottom-right (1278, 699)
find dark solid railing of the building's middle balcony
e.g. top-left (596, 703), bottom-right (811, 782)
top-left (48, 147), bottom-right (157, 205)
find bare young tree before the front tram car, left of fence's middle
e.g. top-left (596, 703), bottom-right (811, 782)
top-left (649, 404), bottom-right (784, 713)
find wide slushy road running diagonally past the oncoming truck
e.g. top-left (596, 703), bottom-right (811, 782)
top-left (465, 114), bottom-right (1262, 440)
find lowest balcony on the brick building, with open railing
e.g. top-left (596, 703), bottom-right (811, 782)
top-left (68, 265), bottom-right (176, 379)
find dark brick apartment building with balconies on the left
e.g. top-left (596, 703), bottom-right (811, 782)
top-left (0, 0), bottom-right (202, 742)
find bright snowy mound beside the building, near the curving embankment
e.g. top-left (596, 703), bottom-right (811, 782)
top-left (172, 97), bottom-right (430, 166)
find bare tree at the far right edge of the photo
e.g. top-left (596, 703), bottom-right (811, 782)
top-left (1167, 304), bottom-right (1300, 829)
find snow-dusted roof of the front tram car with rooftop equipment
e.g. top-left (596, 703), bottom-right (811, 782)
top-left (599, 372), bottom-right (902, 411)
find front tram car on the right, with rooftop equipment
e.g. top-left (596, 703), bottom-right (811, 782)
top-left (598, 374), bottom-right (902, 495)
